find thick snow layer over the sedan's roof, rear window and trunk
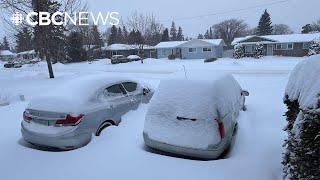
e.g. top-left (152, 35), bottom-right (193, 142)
top-left (27, 75), bottom-right (142, 113)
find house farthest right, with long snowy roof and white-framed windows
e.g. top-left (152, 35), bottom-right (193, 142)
top-left (232, 33), bottom-right (320, 57)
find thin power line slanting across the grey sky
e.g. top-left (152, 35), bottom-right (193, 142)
top-left (160, 0), bottom-right (292, 23)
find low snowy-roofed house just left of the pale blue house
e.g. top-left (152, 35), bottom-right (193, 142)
top-left (101, 44), bottom-right (156, 58)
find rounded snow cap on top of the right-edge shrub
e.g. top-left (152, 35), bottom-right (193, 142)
top-left (285, 55), bottom-right (320, 109)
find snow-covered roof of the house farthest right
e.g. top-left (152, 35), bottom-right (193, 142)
top-left (231, 33), bottom-right (320, 45)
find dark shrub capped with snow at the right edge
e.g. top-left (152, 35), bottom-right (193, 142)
top-left (282, 55), bottom-right (320, 180)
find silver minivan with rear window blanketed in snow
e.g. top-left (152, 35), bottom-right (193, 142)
top-left (143, 74), bottom-right (249, 159)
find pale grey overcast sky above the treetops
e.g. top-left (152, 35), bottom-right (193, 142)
top-left (0, 0), bottom-right (320, 40)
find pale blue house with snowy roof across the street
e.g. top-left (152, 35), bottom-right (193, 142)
top-left (155, 39), bottom-right (225, 59)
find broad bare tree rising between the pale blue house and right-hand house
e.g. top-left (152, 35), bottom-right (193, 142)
top-left (212, 19), bottom-right (248, 46)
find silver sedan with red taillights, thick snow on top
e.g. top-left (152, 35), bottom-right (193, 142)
top-left (21, 76), bottom-right (153, 149)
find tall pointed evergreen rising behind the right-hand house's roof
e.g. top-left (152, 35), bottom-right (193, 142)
top-left (257, 10), bottom-right (273, 36)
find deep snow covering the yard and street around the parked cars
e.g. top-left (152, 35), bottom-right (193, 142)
top-left (0, 57), bottom-right (303, 180)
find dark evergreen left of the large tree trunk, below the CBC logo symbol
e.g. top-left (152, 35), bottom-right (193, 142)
top-left (15, 27), bottom-right (33, 52)
